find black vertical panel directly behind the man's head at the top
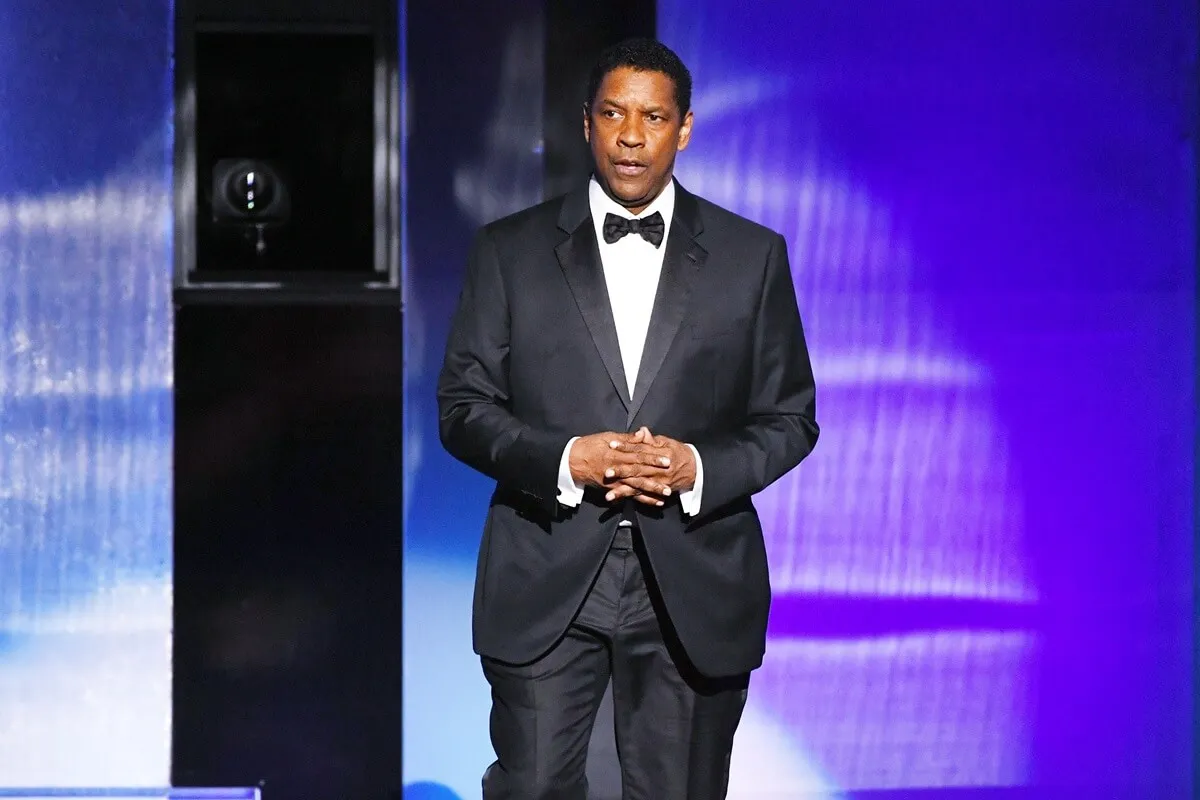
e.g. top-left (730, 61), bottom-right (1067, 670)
top-left (544, 0), bottom-right (656, 198)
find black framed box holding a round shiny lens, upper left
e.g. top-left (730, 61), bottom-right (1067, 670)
top-left (175, 0), bottom-right (401, 296)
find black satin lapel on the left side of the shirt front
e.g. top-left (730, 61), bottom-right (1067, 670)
top-left (547, 217), bottom-right (629, 409)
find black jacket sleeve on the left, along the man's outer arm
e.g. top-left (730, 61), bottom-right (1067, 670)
top-left (438, 228), bottom-right (570, 513)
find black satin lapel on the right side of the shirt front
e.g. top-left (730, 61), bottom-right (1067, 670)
top-left (628, 203), bottom-right (708, 427)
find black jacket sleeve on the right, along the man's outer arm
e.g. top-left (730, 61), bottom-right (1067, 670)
top-left (694, 235), bottom-right (820, 516)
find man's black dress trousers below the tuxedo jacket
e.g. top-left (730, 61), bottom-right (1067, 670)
top-left (482, 528), bottom-right (749, 800)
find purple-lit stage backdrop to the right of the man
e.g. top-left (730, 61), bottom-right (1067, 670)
top-left (659, 0), bottom-right (1195, 798)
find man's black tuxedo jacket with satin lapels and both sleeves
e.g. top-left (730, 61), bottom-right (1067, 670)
top-left (438, 179), bottom-right (818, 676)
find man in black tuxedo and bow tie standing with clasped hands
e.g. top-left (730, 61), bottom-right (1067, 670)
top-left (438, 40), bottom-right (817, 800)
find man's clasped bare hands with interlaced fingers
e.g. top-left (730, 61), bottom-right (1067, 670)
top-left (568, 426), bottom-right (696, 507)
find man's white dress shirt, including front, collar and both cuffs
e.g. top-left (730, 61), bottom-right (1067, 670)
top-left (558, 178), bottom-right (704, 516)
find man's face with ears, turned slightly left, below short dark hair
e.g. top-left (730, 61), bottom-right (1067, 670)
top-left (583, 67), bottom-right (691, 213)
